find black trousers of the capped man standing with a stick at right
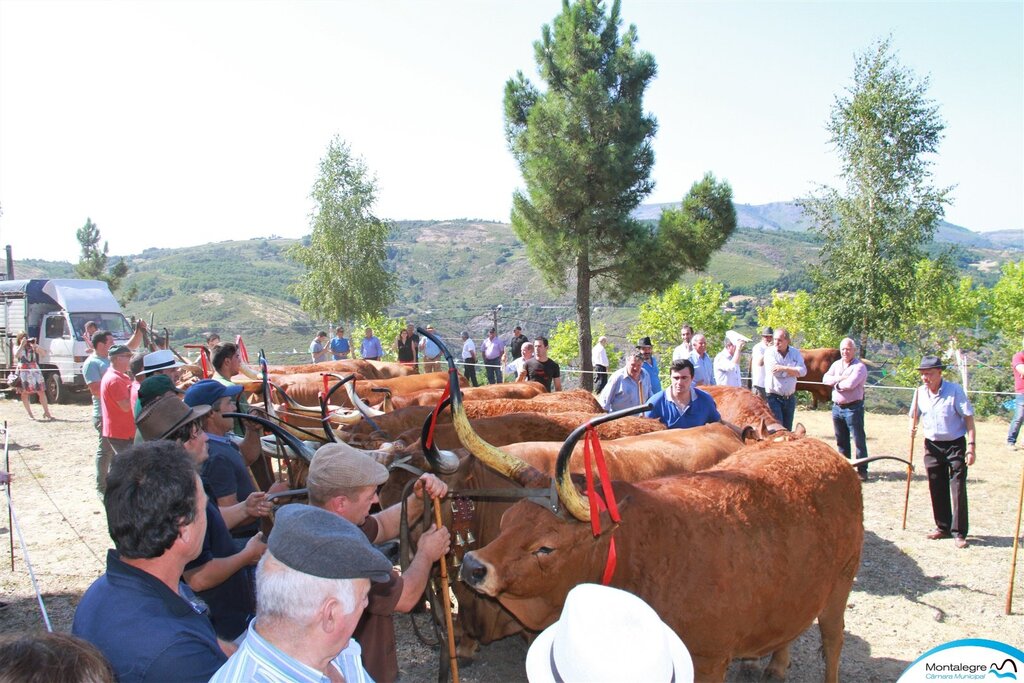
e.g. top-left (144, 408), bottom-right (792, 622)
top-left (925, 436), bottom-right (968, 537)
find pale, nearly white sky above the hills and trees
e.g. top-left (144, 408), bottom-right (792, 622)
top-left (0, 0), bottom-right (1024, 261)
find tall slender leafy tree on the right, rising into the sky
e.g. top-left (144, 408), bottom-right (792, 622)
top-left (801, 40), bottom-right (949, 347)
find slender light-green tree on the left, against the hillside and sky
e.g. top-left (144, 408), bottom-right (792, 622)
top-left (288, 137), bottom-right (398, 325)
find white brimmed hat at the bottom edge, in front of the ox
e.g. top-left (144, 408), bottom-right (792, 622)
top-left (526, 584), bottom-right (693, 683)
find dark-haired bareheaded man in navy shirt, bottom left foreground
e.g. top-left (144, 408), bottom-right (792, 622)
top-left (72, 441), bottom-right (226, 683)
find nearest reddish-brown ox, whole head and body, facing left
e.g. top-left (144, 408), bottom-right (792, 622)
top-left (462, 438), bottom-right (864, 681)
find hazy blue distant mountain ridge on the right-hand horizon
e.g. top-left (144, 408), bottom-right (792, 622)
top-left (633, 202), bottom-right (1024, 250)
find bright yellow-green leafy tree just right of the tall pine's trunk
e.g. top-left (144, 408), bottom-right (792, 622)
top-left (630, 278), bottom-right (729, 385)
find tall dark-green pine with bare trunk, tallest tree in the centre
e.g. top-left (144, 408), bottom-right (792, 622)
top-left (505, 0), bottom-right (735, 388)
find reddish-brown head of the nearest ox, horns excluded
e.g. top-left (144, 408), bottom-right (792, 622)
top-left (461, 493), bottom-right (628, 631)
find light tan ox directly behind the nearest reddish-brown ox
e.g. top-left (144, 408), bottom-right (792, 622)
top-left (395, 387), bottom-right (742, 656)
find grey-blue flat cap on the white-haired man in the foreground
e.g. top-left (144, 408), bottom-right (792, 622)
top-left (267, 504), bottom-right (392, 582)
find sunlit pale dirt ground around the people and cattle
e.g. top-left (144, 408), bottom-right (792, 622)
top-left (0, 399), bottom-right (1024, 683)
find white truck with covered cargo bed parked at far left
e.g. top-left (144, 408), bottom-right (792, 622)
top-left (0, 280), bottom-right (132, 402)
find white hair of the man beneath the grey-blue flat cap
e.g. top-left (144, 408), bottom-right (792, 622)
top-left (256, 551), bottom-right (368, 626)
